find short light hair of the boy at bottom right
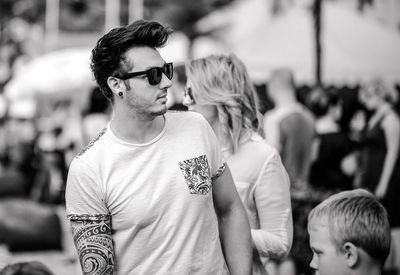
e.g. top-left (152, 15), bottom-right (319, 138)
top-left (308, 189), bottom-right (390, 264)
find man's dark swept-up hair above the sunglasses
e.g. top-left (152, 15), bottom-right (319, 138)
top-left (90, 20), bottom-right (172, 101)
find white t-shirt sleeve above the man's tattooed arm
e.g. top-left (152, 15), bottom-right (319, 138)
top-left (65, 158), bottom-right (109, 219)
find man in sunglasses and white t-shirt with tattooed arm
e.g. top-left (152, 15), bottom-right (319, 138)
top-left (66, 20), bottom-right (252, 274)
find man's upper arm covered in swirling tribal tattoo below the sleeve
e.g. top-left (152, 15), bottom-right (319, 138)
top-left (68, 215), bottom-right (114, 275)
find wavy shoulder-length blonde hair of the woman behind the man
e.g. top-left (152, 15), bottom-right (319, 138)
top-left (186, 54), bottom-right (263, 152)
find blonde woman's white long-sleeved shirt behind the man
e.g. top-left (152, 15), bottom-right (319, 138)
top-left (224, 133), bottom-right (293, 274)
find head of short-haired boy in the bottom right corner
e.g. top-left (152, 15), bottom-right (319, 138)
top-left (308, 189), bottom-right (390, 275)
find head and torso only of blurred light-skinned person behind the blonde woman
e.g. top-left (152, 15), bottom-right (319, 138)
top-left (264, 69), bottom-right (315, 196)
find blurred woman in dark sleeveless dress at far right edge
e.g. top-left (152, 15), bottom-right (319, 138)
top-left (359, 79), bottom-right (400, 274)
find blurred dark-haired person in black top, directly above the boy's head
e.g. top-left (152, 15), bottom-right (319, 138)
top-left (309, 89), bottom-right (355, 199)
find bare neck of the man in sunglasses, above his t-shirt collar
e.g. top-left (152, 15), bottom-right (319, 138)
top-left (110, 106), bottom-right (165, 143)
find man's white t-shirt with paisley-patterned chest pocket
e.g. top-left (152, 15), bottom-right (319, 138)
top-left (66, 112), bottom-right (228, 275)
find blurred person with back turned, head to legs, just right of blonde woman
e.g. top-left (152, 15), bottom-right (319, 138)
top-left (264, 68), bottom-right (316, 275)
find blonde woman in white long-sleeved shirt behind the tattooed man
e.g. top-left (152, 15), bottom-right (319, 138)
top-left (183, 55), bottom-right (293, 274)
